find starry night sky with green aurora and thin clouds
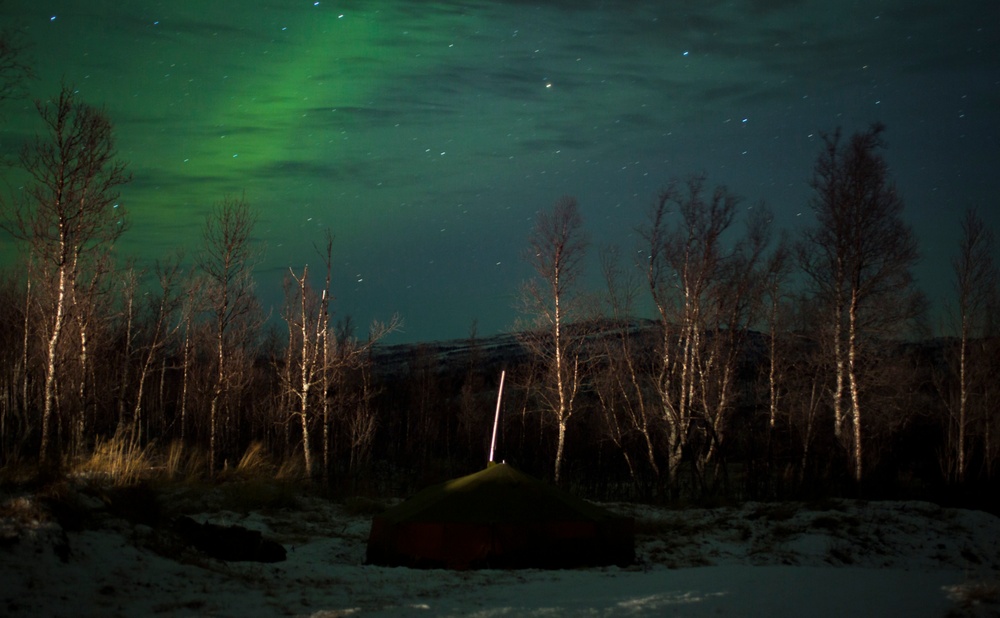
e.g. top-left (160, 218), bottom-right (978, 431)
top-left (0, 0), bottom-right (1000, 342)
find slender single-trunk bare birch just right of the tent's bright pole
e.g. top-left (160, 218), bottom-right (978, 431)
top-left (522, 197), bottom-right (587, 483)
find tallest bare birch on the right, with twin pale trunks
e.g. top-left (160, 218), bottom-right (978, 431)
top-left (797, 124), bottom-right (924, 481)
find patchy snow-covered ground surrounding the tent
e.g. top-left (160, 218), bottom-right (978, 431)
top-left (0, 487), bottom-right (1000, 618)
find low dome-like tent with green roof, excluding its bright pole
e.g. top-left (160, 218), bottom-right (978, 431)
top-left (367, 464), bottom-right (635, 569)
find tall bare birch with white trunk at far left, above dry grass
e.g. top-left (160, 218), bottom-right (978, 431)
top-left (4, 86), bottom-right (130, 461)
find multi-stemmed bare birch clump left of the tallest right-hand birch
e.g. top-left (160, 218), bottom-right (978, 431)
top-left (641, 175), bottom-right (745, 487)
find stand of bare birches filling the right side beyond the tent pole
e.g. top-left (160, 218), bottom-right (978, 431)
top-left (524, 124), bottom-right (1000, 497)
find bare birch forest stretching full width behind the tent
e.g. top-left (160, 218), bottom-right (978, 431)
top-left (0, 67), bottom-right (1000, 508)
